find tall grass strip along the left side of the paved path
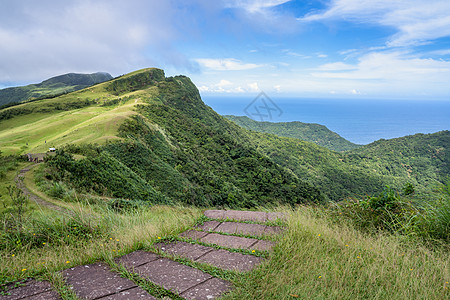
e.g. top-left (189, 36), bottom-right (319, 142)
top-left (0, 206), bottom-right (200, 284)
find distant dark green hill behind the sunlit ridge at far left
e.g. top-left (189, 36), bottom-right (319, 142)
top-left (0, 72), bottom-right (112, 107)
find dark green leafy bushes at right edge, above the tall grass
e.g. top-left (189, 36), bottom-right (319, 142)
top-left (330, 187), bottom-right (450, 242)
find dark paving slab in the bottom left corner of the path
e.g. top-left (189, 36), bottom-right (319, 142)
top-left (0, 279), bottom-right (60, 300)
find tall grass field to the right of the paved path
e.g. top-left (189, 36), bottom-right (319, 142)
top-left (225, 207), bottom-right (450, 300)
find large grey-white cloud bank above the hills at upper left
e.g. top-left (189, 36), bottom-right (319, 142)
top-left (0, 0), bottom-right (201, 82)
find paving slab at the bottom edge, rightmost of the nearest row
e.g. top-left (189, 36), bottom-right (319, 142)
top-left (181, 277), bottom-right (232, 300)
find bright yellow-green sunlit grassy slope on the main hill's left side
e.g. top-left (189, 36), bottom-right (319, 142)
top-left (0, 74), bottom-right (158, 155)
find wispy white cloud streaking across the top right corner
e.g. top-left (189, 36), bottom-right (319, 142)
top-left (299, 0), bottom-right (450, 47)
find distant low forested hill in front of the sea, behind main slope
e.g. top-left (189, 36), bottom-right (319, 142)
top-left (224, 115), bottom-right (360, 151)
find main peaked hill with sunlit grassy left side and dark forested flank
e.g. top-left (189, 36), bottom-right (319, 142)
top-left (0, 69), bottom-right (324, 207)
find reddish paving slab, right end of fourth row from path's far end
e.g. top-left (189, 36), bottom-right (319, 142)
top-left (197, 250), bottom-right (262, 272)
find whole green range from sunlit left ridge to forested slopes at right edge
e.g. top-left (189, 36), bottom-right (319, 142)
top-left (0, 69), bottom-right (450, 207)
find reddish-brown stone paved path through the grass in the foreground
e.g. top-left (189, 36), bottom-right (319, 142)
top-left (0, 210), bottom-right (283, 300)
